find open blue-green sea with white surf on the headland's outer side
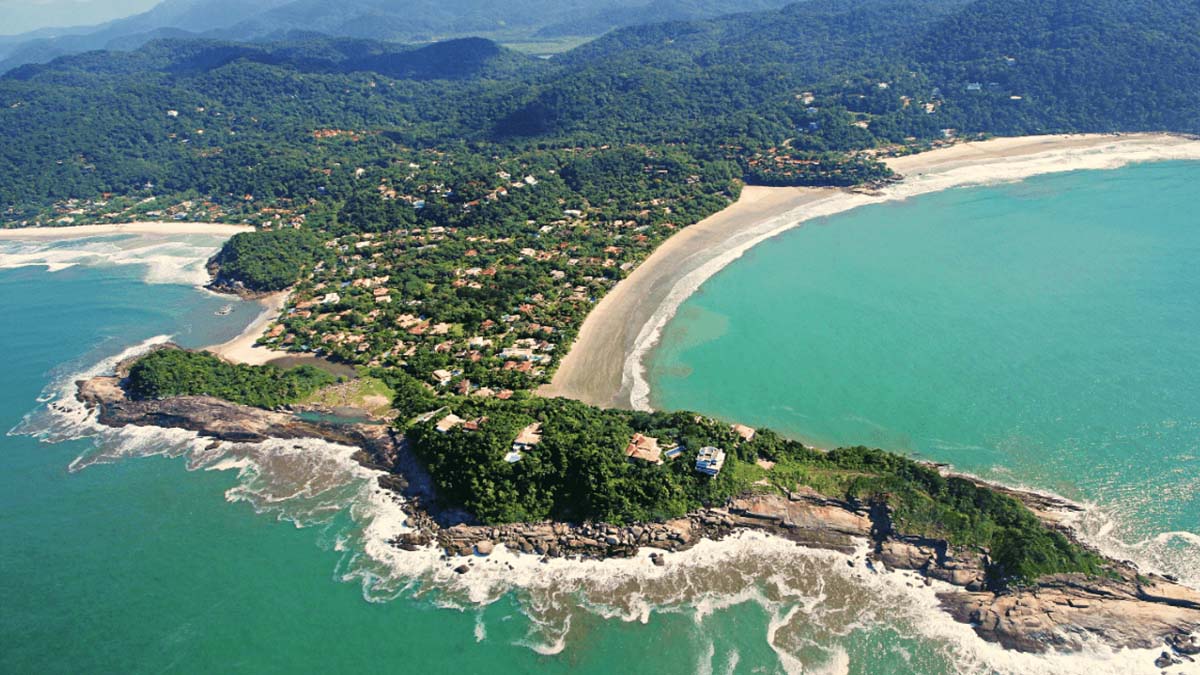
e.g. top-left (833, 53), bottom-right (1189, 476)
top-left (0, 238), bottom-right (974, 673)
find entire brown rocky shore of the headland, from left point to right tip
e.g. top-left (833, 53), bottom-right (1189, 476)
top-left (78, 368), bottom-right (1200, 667)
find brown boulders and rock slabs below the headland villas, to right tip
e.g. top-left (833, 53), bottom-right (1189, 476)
top-left (410, 478), bottom-right (1200, 664)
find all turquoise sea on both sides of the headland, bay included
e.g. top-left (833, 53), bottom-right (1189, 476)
top-left (0, 165), bottom-right (1200, 674)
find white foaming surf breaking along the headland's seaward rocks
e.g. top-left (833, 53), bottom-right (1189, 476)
top-left (13, 335), bottom-right (1200, 675)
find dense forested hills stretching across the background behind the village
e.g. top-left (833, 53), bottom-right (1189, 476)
top-left (0, 0), bottom-right (1200, 222)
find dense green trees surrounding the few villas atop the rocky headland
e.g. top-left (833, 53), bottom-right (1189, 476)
top-left (407, 391), bottom-right (1102, 590)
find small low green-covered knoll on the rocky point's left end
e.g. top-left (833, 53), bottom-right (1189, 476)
top-left (127, 350), bottom-right (337, 408)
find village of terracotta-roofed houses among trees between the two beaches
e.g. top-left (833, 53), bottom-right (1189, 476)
top-left (265, 156), bottom-right (696, 398)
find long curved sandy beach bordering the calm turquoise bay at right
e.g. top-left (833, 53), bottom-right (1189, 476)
top-left (540, 133), bottom-right (1200, 410)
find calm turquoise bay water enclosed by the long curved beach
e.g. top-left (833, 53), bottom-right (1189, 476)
top-left (648, 162), bottom-right (1200, 584)
